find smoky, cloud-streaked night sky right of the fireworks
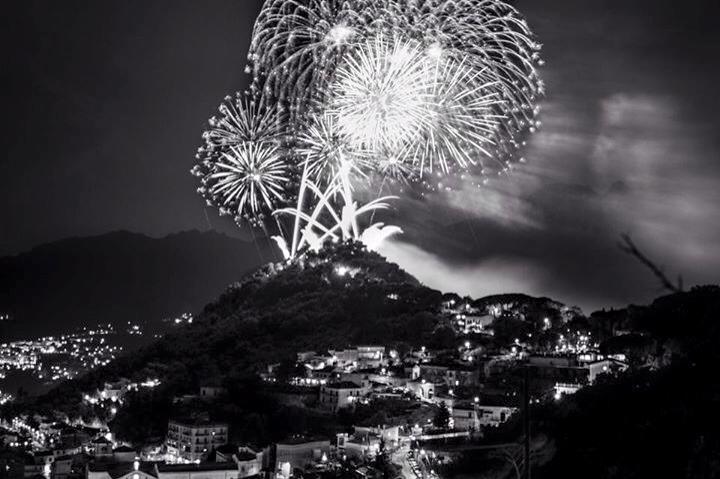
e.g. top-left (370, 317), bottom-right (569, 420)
top-left (384, 1), bottom-right (720, 309)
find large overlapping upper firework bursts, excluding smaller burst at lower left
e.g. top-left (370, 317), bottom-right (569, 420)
top-left (249, 0), bottom-right (544, 181)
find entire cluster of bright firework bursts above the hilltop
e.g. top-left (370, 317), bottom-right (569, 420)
top-left (193, 0), bottom-right (544, 254)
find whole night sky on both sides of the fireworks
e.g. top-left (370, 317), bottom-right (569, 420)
top-left (0, 0), bottom-right (720, 310)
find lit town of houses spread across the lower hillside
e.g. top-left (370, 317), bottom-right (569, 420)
top-left (0, 294), bottom-right (629, 479)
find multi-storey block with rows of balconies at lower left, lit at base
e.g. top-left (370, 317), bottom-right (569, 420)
top-left (165, 419), bottom-right (228, 462)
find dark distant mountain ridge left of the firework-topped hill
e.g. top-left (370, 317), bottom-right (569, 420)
top-left (0, 231), bottom-right (273, 339)
